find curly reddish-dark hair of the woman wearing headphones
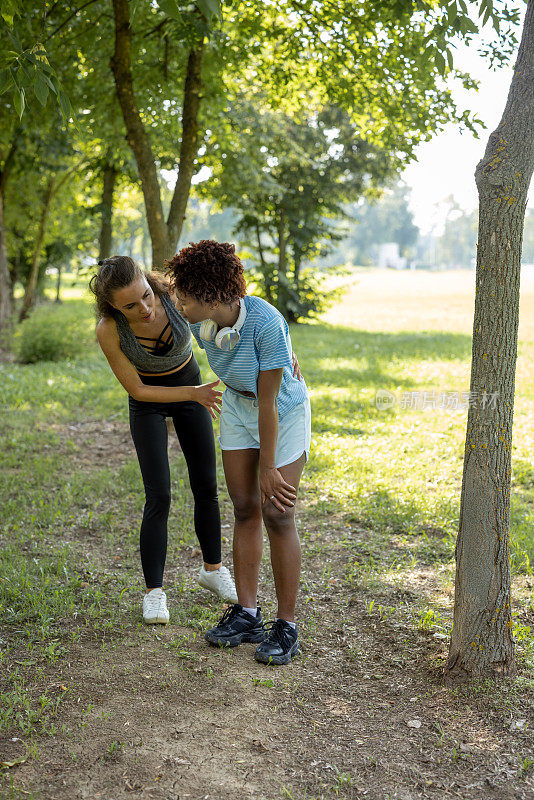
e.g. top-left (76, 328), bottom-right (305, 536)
top-left (165, 239), bottom-right (247, 303)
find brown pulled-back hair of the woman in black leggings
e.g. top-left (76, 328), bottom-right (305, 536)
top-left (89, 256), bottom-right (170, 319)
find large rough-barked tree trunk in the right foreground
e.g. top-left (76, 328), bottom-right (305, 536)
top-left (445, 0), bottom-right (534, 680)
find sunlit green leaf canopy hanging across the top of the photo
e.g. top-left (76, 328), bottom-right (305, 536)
top-left (0, 0), bottom-right (528, 316)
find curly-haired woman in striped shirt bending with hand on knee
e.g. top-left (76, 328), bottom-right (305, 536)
top-left (168, 240), bottom-right (311, 664)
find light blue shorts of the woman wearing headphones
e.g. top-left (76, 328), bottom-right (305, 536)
top-left (217, 389), bottom-right (311, 468)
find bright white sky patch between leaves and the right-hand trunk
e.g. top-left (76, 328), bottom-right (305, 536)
top-left (402, 2), bottom-right (534, 234)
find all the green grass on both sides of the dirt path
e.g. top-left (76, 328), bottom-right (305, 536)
top-left (0, 276), bottom-right (534, 744)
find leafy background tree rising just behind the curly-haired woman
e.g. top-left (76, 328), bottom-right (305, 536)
top-left (204, 100), bottom-right (398, 322)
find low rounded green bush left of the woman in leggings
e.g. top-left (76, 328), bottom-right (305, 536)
top-left (16, 305), bottom-right (93, 364)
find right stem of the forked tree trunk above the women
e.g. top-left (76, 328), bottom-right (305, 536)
top-left (167, 43), bottom-right (204, 250)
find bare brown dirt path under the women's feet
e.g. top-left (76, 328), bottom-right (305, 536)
top-left (0, 425), bottom-right (534, 800)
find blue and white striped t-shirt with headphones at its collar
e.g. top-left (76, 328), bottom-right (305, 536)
top-left (189, 295), bottom-right (308, 419)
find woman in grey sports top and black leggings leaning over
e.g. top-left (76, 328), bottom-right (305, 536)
top-left (90, 256), bottom-right (237, 623)
